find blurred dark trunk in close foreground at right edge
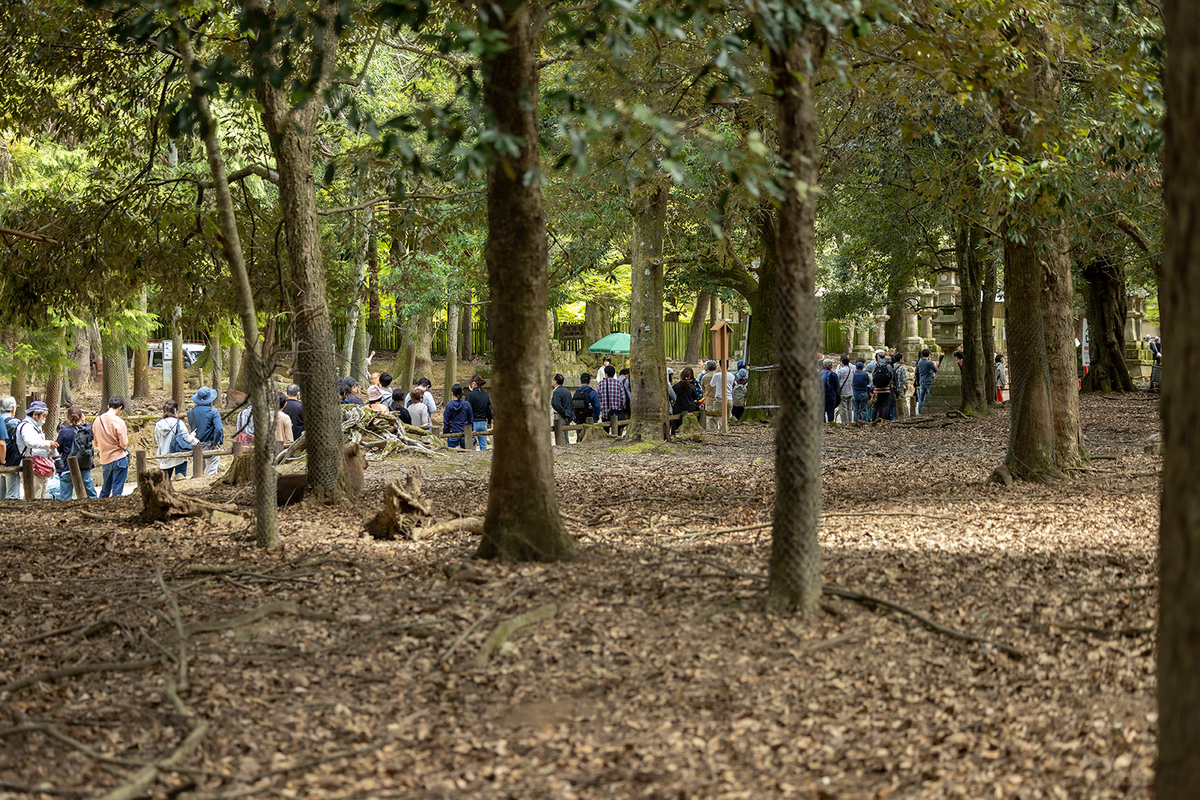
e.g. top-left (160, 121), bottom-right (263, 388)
top-left (1154, 0), bottom-right (1200, 800)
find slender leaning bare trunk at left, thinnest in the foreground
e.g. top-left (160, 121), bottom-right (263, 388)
top-left (181, 25), bottom-right (279, 549)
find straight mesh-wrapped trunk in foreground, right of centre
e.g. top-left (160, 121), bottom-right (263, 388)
top-left (767, 28), bottom-right (828, 616)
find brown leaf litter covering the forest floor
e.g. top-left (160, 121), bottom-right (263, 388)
top-left (0, 395), bottom-right (1160, 800)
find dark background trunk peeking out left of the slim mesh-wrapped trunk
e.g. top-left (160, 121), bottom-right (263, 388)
top-left (742, 206), bottom-right (782, 420)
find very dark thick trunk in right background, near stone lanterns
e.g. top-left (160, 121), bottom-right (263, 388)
top-left (1082, 254), bottom-right (1133, 393)
